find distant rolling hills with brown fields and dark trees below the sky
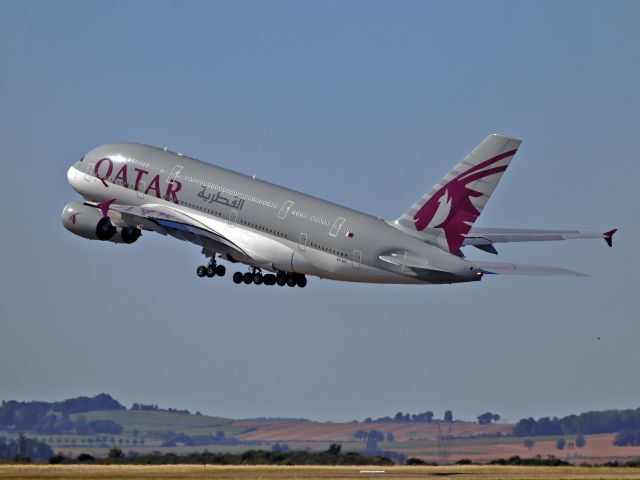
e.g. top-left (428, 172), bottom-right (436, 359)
top-left (0, 393), bottom-right (640, 463)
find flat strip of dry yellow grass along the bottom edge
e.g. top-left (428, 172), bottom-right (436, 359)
top-left (0, 465), bottom-right (640, 480)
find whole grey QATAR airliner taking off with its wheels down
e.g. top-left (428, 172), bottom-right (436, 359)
top-left (62, 134), bottom-right (616, 287)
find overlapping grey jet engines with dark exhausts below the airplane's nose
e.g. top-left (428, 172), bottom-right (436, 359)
top-left (62, 202), bottom-right (142, 243)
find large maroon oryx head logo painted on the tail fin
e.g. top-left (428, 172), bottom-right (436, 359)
top-left (413, 149), bottom-right (517, 253)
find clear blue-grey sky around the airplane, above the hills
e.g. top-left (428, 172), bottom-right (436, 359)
top-left (0, 0), bottom-right (640, 420)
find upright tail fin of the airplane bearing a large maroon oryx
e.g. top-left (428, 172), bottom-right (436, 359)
top-left (392, 133), bottom-right (521, 253)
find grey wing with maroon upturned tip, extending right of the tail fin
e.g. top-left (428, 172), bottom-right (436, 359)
top-left (462, 228), bottom-right (618, 254)
